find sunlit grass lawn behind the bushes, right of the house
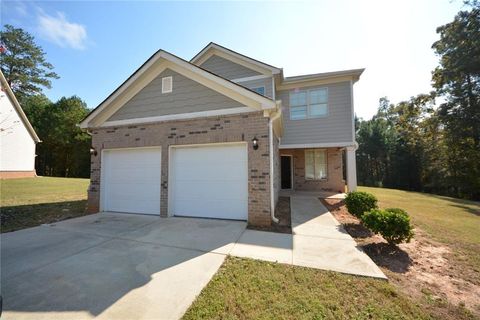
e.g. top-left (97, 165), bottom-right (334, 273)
top-left (359, 187), bottom-right (480, 283)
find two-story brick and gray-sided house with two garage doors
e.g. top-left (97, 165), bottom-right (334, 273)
top-left (80, 43), bottom-right (363, 225)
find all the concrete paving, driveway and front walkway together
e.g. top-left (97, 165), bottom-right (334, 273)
top-left (1, 196), bottom-right (385, 320)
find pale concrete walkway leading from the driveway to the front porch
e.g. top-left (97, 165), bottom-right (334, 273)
top-left (230, 195), bottom-right (386, 279)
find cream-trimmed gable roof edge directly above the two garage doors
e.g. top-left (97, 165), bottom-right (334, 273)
top-left (80, 50), bottom-right (276, 128)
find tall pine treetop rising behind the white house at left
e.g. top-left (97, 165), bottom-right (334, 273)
top-left (0, 24), bottom-right (59, 101)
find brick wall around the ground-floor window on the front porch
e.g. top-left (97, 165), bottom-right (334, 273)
top-left (280, 148), bottom-right (345, 192)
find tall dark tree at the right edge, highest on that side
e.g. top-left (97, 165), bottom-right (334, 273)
top-left (432, 1), bottom-right (480, 199)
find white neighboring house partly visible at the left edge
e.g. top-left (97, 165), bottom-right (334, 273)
top-left (0, 71), bottom-right (40, 179)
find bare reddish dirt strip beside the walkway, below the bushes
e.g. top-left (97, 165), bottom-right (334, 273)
top-left (321, 199), bottom-right (480, 319)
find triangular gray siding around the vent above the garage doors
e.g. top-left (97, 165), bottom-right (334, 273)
top-left (109, 69), bottom-right (244, 120)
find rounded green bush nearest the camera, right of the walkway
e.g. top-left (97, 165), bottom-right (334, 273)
top-left (362, 208), bottom-right (413, 244)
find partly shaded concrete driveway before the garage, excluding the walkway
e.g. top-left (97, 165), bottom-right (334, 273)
top-left (1, 213), bottom-right (246, 319)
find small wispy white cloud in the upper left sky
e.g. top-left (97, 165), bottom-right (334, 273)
top-left (38, 11), bottom-right (87, 50)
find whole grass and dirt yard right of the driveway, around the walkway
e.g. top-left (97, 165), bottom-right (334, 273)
top-left (184, 188), bottom-right (480, 320)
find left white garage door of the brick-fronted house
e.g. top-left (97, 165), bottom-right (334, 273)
top-left (102, 148), bottom-right (161, 214)
